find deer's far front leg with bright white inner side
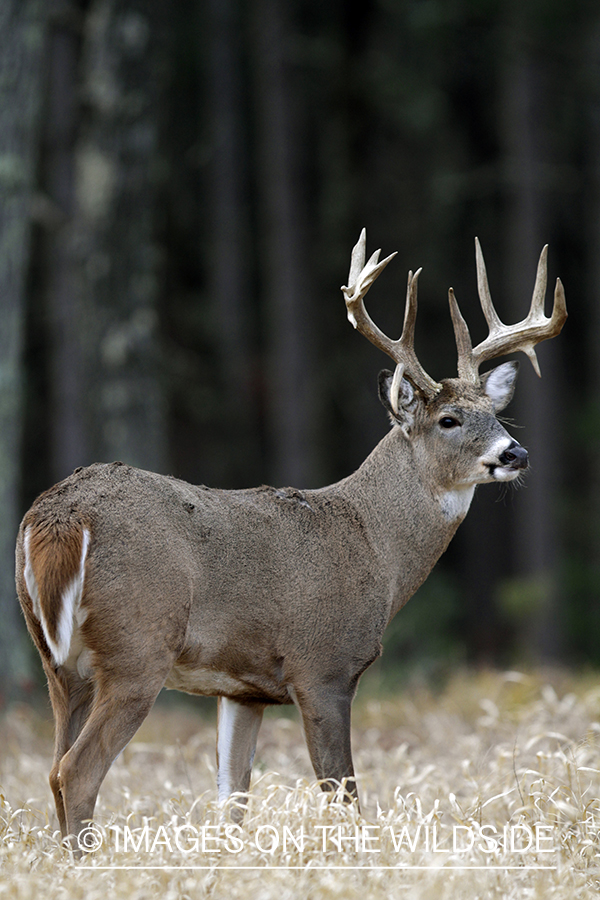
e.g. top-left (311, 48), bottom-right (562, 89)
top-left (217, 697), bottom-right (264, 822)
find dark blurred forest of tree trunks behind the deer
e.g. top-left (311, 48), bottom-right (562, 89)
top-left (0, 0), bottom-right (600, 705)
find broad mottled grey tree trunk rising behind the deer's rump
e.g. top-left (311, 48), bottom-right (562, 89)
top-left (53, 0), bottom-right (166, 476)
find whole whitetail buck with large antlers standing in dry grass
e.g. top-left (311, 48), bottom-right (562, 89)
top-left (16, 230), bottom-right (567, 854)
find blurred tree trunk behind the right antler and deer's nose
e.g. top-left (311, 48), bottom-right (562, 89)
top-left (502, 4), bottom-right (562, 661)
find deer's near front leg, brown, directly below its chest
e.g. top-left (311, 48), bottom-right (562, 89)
top-left (296, 686), bottom-right (358, 802)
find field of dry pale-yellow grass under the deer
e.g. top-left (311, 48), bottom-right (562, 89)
top-left (0, 672), bottom-right (600, 900)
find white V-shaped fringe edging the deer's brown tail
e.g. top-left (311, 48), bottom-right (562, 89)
top-left (24, 528), bottom-right (90, 666)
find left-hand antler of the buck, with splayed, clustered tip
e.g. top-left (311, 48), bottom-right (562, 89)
top-left (342, 228), bottom-right (442, 399)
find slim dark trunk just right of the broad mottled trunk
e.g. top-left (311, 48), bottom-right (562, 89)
top-left (207, 0), bottom-right (260, 486)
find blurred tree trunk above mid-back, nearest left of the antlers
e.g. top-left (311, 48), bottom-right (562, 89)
top-left (253, 0), bottom-right (315, 487)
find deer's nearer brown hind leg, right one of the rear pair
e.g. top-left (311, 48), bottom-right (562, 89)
top-left (56, 673), bottom-right (166, 855)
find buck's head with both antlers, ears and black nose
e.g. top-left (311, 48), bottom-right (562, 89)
top-left (342, 229), bottom-right (567, 484)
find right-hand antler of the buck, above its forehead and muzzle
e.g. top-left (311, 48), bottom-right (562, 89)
top-left (448, 238), bottom-right (567, 384)
